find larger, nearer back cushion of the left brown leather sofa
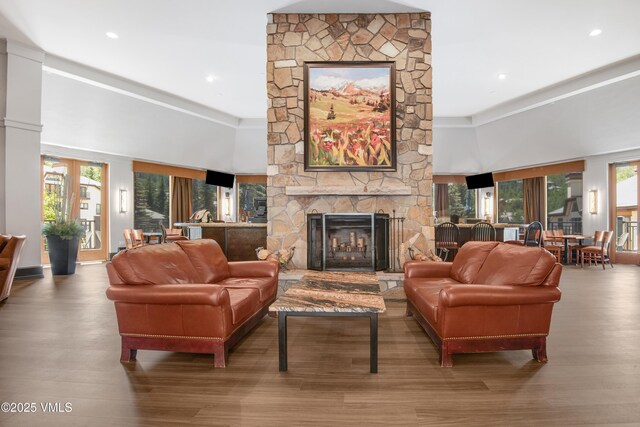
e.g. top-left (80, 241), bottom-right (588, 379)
top-left (111, 244), bottom-right (201, 285)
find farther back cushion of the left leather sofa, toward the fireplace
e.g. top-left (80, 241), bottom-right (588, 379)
top-left (174, 239), bottom-right (229, 283)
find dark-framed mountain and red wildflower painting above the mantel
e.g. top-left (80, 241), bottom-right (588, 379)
top-left (304, 62), bottom-right (397, 171)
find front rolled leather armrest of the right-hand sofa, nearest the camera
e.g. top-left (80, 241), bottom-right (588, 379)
top-left (439, 284), bottom-right (560, 307)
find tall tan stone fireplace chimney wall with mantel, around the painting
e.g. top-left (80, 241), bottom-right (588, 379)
top-left (267, 12), bottom-right (434, 269)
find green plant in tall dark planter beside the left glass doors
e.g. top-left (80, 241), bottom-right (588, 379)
top-left (42, 176), bottom-right (84, 275)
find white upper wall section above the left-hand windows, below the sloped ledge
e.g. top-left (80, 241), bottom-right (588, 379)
top-left (42, 73), bottom-right (235, 172)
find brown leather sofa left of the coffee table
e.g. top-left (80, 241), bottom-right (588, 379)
top-left (107, 239), bottom-right (278, 367)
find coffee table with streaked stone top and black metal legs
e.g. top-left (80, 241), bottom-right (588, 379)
top-left (269, 272), bottom-right (385, 373)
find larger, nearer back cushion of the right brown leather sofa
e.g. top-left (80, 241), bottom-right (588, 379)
top-left (472, 245), bottom-right (556, 286)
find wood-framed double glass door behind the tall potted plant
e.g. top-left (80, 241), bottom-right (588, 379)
top-left (41, 156), bottom-right (108, 264)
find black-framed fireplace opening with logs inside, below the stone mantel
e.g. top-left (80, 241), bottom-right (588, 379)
top-left (307, 213), bottom-right (389, 271)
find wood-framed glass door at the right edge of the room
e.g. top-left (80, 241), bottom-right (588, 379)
top-left (611, 161), bottom-right (640, 264)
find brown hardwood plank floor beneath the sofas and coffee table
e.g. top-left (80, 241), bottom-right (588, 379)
top-left (0, 265), bottom-right (640, 426)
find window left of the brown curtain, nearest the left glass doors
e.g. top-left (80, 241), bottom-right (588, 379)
top-left (133, 172), bottom-right (169, 231)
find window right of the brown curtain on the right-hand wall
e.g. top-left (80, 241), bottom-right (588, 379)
top-left (547, 172), bottom-right (582, 234)
